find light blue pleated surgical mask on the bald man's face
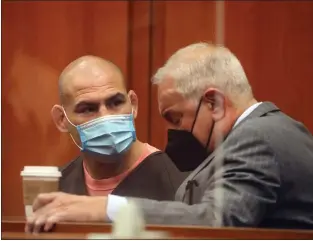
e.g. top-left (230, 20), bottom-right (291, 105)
top-left (64, 110), bottom-right (136, 156)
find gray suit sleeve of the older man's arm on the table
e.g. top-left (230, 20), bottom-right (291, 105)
top-left (127, 127), bottom-right (280, 227)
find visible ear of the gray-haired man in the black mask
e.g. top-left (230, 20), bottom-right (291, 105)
top-left (203, 88), bottom-right (225, 121)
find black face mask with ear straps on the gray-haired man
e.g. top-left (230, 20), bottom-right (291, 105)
top-left (165, 99), bottom-right (214, 172)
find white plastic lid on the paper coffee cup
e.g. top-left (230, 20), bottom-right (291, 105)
top-left (21, 166), bottom-right (62, 177)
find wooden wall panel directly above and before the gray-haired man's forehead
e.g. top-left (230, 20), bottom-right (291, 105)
top-left (150, 1), bottom-right (215, 149)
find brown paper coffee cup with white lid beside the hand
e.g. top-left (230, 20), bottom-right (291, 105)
top-left (21, 166), bottom-right (62, 217)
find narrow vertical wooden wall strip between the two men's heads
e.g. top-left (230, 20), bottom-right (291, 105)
top-left (127, 1), bottom-right (151, 142)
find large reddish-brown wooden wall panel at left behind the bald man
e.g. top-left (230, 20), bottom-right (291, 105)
top-left (1, 1), bottom-right (128, 216)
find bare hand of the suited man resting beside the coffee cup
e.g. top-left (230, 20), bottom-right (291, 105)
top-left (25, 192), bottom-right (107, 233)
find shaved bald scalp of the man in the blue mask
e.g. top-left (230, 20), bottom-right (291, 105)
top-left (59, 55), bottom-right (126, 104)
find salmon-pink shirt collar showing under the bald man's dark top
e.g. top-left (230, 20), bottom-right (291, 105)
top-left (83, 143), bottom-right (159, 196)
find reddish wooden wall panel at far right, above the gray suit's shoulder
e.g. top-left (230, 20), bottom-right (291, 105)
top-left (225, 1), bottom-right (313, 132)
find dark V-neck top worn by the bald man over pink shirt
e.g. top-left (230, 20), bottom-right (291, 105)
top-left (59, 151), bottom-right (188, 201)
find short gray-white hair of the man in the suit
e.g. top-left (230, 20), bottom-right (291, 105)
top-left (152, 43), bottom-right (253, 104)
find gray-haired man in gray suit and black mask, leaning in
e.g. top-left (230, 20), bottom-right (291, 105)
top-left (26, 43), bottom-right (313, 231)
